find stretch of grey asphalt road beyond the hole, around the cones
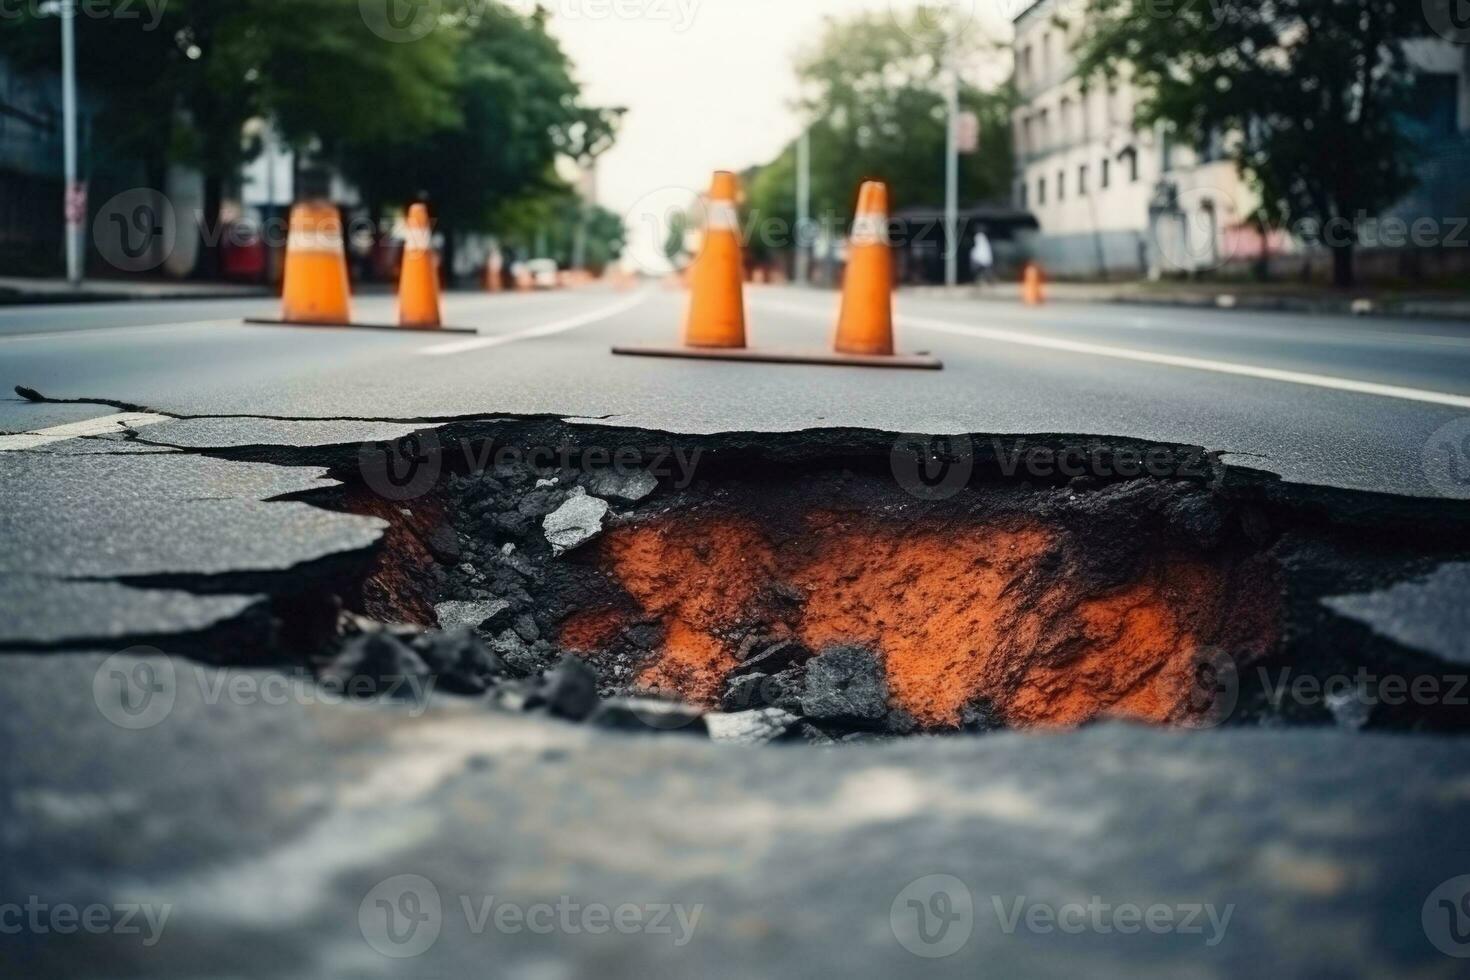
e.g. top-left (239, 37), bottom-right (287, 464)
top-left (0, 287), bottom-right (1470, 495)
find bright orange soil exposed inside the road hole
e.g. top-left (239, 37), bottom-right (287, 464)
top-left (562, 513), bottom-right (1274, 727)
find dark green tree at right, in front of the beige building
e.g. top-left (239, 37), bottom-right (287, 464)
top-left (1078, 0), bottom-right (1427, 287)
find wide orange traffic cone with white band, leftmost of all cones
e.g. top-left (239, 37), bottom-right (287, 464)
top-left (281, 201), bottom-right (351, 323)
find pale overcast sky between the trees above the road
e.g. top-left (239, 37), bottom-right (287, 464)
top-left (541, 0), bottom-right (1016, 264)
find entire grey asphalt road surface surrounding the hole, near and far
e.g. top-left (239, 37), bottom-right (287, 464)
top-left (0, 279), bottom-right (1470, 977)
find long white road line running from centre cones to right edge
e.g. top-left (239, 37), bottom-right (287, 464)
top-left (757, 296), bottom-right (1470, 408)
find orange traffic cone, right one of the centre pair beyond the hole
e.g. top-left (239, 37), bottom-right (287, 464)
top-left (833, 181), bottom-right (894, 356)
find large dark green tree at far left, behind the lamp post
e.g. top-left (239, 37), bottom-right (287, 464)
top-left (0, 0), bottom-right (459, 275)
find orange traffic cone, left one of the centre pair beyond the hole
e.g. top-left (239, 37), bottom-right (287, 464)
top-left (684, 170), bottom-right (745, 348)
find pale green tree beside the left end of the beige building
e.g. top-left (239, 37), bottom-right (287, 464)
top-left (748, 13), bottom-right (1014, 257)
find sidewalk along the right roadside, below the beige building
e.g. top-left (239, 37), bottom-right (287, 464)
top-left (904, 282), bottom-right (1470, 320)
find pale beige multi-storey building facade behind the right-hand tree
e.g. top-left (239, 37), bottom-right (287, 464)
top-left (1011, 0), bottom-right (1470, 278)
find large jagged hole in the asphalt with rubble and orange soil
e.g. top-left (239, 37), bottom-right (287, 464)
top-left (310, 426), bottom-right (1470, 741)
